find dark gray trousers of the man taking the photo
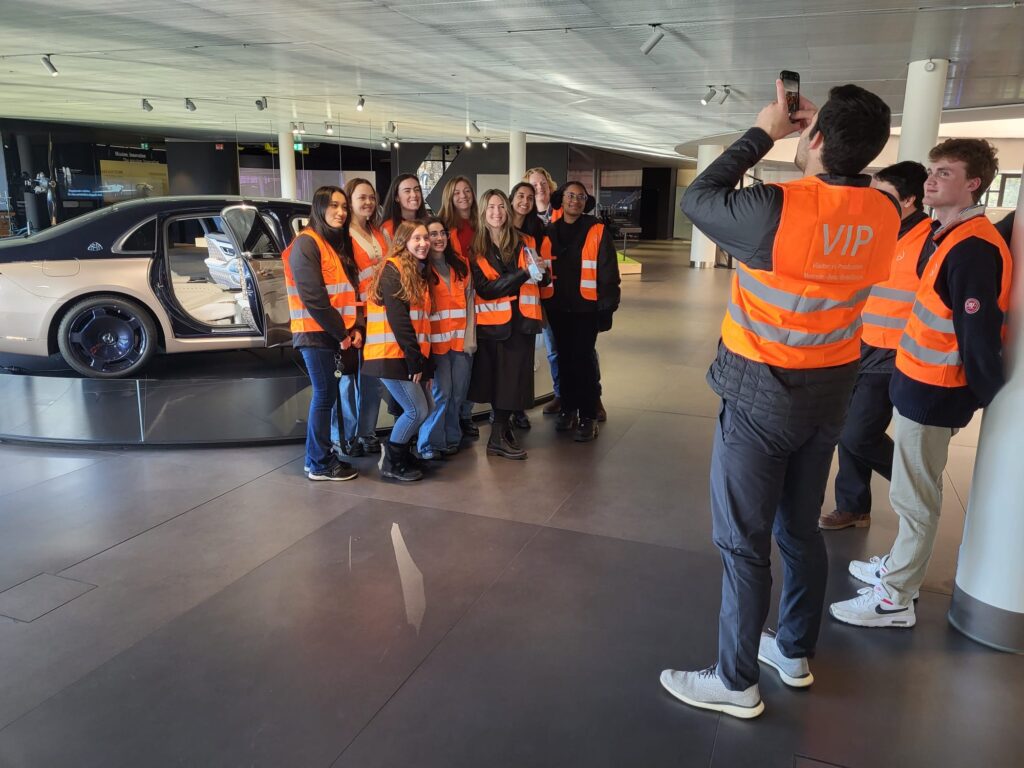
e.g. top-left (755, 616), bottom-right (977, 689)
top-left (711, 400), bottom-right (843, 690)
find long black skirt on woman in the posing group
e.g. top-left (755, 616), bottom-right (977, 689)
top-left (468, 332), bottom-right (537, 411)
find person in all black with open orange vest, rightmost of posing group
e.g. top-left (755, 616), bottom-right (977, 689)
top-left (544, 181), bottom-right (620, 442)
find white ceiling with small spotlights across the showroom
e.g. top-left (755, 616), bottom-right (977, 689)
top-left (0, 0), bottom-right (1024, 157)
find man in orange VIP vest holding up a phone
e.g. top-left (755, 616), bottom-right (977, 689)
top-left (660, 81), bottom-right (899, 718)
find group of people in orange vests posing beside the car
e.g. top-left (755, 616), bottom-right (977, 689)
top-left (284, 168), bottom-right (620, 481)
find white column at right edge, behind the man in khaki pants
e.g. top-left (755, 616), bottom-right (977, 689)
top-left (949, 173), bottom-right (1024, 653)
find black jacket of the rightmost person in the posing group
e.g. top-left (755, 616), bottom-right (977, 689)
top-left (544, 215), bottom-right (622, 313)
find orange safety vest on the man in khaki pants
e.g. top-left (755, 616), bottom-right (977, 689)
top-left (896, 214), bottom-right (1013, 387)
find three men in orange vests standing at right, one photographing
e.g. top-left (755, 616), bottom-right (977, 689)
top-left (660, 82), bottom-right (1012, 718)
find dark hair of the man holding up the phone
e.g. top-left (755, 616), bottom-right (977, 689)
top-left (811, 85), bottom-right (892, 176)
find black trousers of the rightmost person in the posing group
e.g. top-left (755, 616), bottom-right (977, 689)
top-left (548, 309), bottom-right (601, 419)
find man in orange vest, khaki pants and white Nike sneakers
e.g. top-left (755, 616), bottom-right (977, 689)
top-left (829, 138), bottom-right (1013, 628)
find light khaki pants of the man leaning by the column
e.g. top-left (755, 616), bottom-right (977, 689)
top-left (882, 409), bottom-right (956, 605)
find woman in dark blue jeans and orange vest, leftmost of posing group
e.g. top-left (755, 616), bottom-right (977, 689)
top-left (283, 186), bottom-right (364, 480)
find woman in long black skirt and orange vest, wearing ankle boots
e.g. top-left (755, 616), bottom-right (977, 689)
top-left (469, 189), bottom-right (551, 459)
